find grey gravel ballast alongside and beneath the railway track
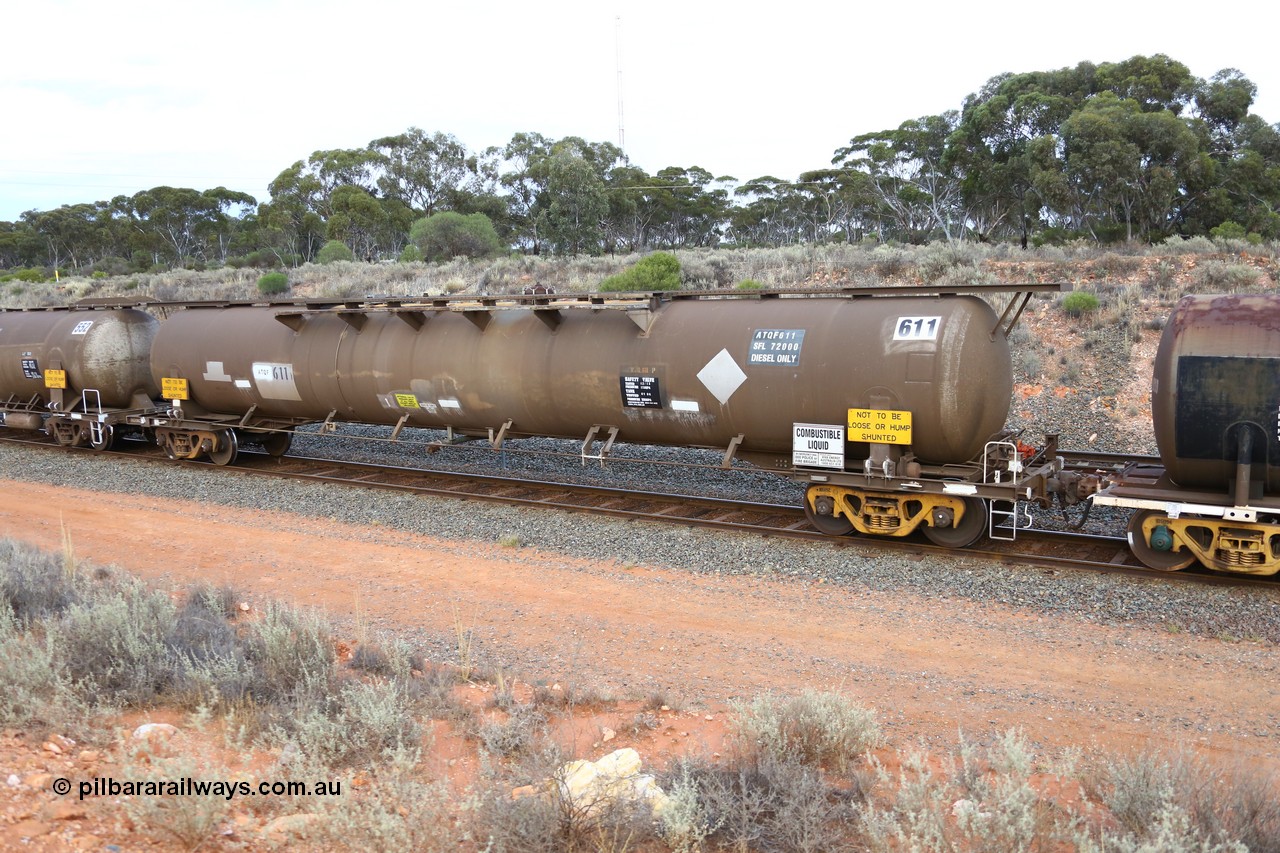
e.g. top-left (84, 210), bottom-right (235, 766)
top-left (0, 428), bottom-right (1280, 643)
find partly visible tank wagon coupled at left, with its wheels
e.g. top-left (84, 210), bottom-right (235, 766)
top-left (0, 307), bottom-right (159, 450)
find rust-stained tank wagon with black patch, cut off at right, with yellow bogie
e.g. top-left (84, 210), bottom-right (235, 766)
top-left (1093, 295), bottom-right (1280, 575)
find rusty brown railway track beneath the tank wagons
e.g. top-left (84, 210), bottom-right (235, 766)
top-left (0, 435), bottom-right (1275, 588)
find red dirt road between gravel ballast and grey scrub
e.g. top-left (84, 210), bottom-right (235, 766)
top-left (0, 482), bottom-right (1280, 765)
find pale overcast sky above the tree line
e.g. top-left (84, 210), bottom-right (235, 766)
top-left (0, 0), bottom-right (1280, 220)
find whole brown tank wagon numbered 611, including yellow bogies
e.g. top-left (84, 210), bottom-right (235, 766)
top-left (135, 288), bottom-right (1056, 546)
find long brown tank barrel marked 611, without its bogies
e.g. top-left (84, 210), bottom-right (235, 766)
top-left (152, 296), bottom-right (1012, 462)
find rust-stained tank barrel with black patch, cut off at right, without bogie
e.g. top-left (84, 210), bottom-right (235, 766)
top-left (1151, 295), bottom-right (1280, 497)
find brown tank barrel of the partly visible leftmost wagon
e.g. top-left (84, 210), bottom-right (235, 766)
top-left (0, 309), bottom-right (157, 409)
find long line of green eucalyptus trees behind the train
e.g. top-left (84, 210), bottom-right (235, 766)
top-left (0, 54), bottom-right (1280, 273)
